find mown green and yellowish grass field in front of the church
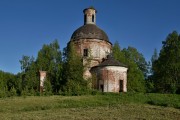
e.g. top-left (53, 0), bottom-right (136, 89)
top-left (0, 93), bottom-right (180, 120)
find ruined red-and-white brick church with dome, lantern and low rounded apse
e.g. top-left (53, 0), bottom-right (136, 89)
top-left (40, 7), bottom-right (128, 92)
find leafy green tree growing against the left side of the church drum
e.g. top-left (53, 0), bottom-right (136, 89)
top-left (63, 42), bottom-right (87, 95)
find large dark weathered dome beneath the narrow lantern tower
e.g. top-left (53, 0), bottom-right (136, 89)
top-left (71, 24), bottom-right (109, 41)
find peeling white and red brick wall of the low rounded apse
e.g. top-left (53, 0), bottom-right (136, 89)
top-left (93, 66), bottom-right (127, 92)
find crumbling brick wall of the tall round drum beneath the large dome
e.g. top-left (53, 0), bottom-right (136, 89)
top-left (73, 39), bottom-right (112, 78)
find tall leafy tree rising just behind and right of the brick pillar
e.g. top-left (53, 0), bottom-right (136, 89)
top-left (36, 40), bottom-right (62, 93)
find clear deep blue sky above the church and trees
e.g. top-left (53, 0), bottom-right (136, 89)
top-left (0, 0), bottom-right (180, 73)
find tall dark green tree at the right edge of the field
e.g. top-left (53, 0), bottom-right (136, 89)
top-left (152, 31), bottom-right (180, 93)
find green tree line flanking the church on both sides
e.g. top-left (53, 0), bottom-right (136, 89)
top-left (0, 31), bottom-right (180, 97)
